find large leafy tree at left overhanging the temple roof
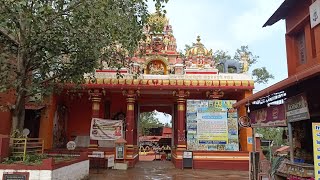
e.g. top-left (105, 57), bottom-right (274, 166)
top-left (0, 0), bottom-right (167, 130)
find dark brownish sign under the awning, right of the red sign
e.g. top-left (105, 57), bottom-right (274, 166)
top-left (285, 94), bottom-right (310, 122)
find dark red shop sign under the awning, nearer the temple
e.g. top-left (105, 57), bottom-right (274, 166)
top-left (249, 104), bottom-right (287, 127)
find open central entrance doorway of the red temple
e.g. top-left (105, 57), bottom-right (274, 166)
top-left (137, 104), bottom-right (174, 161)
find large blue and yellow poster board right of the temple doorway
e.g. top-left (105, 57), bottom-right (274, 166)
top-left (186, 100), bottom-right (239, 151)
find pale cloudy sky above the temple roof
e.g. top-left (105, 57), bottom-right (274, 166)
top-left (149, 0), bottom-right (287, 124)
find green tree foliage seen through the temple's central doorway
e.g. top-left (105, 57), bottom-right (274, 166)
top-left (138, 111), bottom-right (164, 136)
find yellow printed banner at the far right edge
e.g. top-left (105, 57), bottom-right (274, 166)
top-left (312, 123), bottom-right (320, 179)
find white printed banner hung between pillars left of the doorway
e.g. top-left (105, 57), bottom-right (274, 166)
top-left (90, 118), bottom-right (123, 140)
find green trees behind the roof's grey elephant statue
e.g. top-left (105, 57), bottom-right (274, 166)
top-left (213, 46), bottom-right (274, 84)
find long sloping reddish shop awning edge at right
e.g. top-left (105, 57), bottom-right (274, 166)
top-left (233, 64), bottom-right (320, 108)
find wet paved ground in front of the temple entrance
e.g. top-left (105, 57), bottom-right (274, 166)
top-left (90, 161), bottom-right (249, 180)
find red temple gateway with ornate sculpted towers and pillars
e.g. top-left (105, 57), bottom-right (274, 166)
top-left (26, 12), bottom-right (254, 170)
